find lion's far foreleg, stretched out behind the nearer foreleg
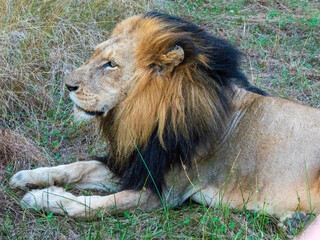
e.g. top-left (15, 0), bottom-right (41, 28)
top-left (10, 161), bottom-right (118, 192)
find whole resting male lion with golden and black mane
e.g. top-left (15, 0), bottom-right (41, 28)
top-left (10, 12), bottom-right (320, 220)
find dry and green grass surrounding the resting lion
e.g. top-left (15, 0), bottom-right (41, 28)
top-left (0, 0), bottom-right (320, 239)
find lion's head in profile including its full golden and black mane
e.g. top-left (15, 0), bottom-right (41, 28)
top-left (66, 12), bottom-right (264, 193)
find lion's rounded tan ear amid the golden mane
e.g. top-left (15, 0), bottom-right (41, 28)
top-left (157, 45), bottom-right (184, 76)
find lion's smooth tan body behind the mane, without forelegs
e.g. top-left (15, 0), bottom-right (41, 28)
top-left (186, 93), bottom-right (320, 216)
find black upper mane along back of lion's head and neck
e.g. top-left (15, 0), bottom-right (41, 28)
top-left (144, 12), bottom-right (267, 96)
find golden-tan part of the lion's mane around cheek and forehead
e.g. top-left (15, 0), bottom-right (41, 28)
top-left (101, 16), bottom-right (225, 161)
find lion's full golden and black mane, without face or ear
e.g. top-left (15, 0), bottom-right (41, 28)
top-left (98, 12), bottom-right (264, 192)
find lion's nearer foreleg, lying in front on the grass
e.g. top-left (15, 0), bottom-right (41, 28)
top-left (21, 187), bottom-right (161, 218)
